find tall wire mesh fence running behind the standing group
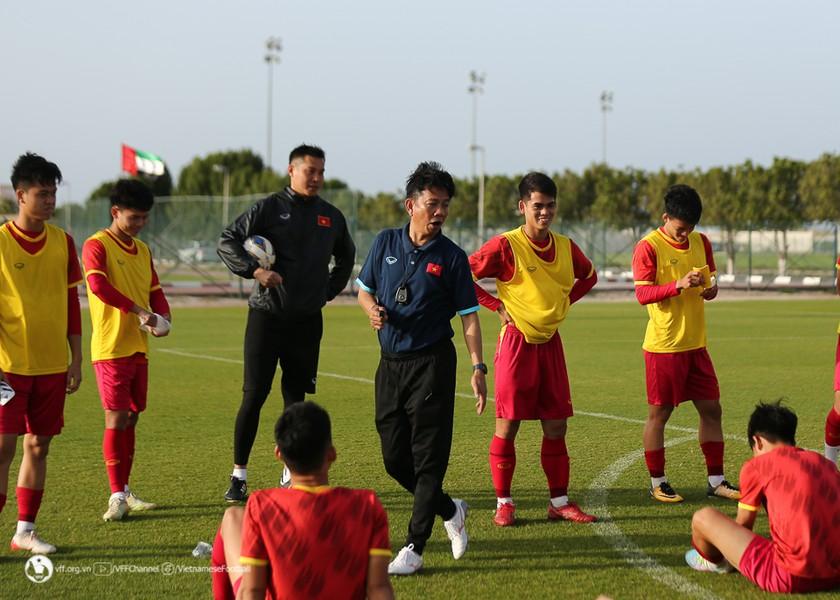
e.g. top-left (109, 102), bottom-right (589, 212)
top-left (54, 190), bottom-right (838, 293)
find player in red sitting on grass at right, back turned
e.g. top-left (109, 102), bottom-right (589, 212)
top-left (685, 402), bottom-right (840, 593)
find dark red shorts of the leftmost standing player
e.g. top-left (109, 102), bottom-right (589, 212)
top-left (0, 373), bottom-right (67, 435)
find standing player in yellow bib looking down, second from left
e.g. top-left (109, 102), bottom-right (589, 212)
top-left (82, 179), bottom-right (171, 521)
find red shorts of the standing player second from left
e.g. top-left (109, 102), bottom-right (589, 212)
top-left (93, 353), bottom-right (149, 413)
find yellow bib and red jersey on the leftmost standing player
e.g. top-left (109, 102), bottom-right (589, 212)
top-left (0, 221), bottom-right (82, 375)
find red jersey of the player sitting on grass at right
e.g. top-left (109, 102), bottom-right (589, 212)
top-left (738, 446), bottom-right (840, 578)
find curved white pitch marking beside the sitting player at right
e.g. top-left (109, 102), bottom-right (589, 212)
top-left (586, 435), bottom-right (717, 600)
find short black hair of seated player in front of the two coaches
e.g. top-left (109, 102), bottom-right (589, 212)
top-left (274, 402), bottom-right (332, 475)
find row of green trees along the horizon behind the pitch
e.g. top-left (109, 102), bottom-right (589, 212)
top-left (83, 150), bottom-right (840, 272)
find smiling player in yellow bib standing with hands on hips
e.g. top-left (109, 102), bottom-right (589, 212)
top-left (470, 173), bottom-right (598, 527)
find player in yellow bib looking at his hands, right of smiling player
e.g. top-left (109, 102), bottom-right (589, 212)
top-left (633, 185), bottom-right (740, 502)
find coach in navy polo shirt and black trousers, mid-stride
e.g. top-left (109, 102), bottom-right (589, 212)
top-left (356, 162), bottom-right (487, 575)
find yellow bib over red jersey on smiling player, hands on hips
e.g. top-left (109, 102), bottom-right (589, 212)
top-left (469, 227), bottom-right (597, 344)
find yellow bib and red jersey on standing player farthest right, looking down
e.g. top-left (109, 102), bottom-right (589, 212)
top-left (633, 229), bottom-right (716, 353)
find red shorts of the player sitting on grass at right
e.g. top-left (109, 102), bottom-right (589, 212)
top-left (738, 535), bottom-right (840, 594)
